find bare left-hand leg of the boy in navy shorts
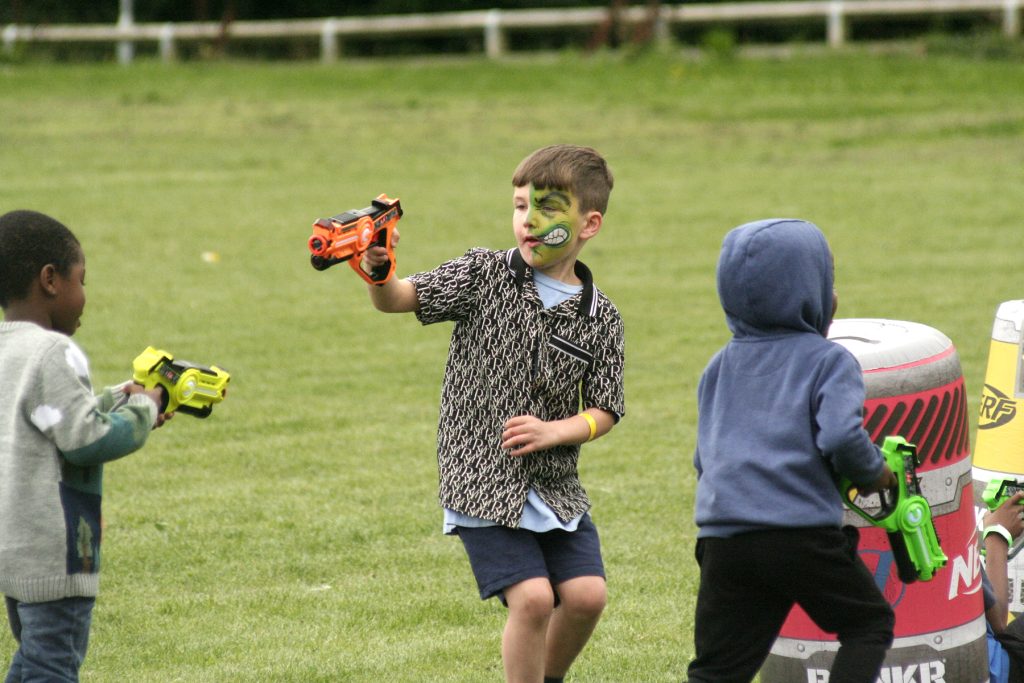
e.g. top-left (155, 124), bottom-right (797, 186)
top-left (502, 579), bottom-right (555, 683)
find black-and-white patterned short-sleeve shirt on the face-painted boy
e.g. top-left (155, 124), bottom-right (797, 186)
top-left (409, 249), bottom-right (625, 527)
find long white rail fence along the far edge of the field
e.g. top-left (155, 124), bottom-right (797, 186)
top-left (0, 0), bottom-right (1024, 63)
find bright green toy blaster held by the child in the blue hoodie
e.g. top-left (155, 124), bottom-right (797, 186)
top-left (840, 436), bottom-right (946, 584)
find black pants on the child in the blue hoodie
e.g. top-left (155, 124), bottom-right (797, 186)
top-left (688, 527), bottom-right (895, 683)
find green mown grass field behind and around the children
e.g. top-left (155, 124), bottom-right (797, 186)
top-left (0, 44), bottom-right (1024, 683)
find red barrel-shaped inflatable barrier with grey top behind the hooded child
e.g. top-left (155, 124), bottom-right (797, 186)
top-left (761, 318), bottom-right (988, 683)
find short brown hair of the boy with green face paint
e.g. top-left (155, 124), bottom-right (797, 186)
top-left (512, 144), bottom-right (614, 214)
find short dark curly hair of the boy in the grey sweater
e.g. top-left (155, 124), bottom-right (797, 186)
top-left (0, 210), bottom-right (82, 308)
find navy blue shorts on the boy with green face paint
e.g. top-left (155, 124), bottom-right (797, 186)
top-left (456, 515), bottom-right (604, 604)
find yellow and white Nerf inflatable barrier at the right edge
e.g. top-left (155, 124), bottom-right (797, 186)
top-left (974, 300), bottom-right (1024, 616)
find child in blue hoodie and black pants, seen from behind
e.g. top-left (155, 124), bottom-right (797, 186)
top-left (688, 219), bottom-right (895, 683)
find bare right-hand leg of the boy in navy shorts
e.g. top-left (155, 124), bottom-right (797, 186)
top-left (545, 577), bottom-right (607, 678)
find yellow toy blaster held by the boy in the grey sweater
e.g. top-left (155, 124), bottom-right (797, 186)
top-left (132, 346), bottom-right (231, 418)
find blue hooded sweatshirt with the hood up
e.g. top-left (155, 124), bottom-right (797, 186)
top-left (693, 219), bottom-right (883, 537)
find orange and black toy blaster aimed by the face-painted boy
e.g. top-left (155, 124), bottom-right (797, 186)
top-left (308, 195), bottom-right (402, 285)
